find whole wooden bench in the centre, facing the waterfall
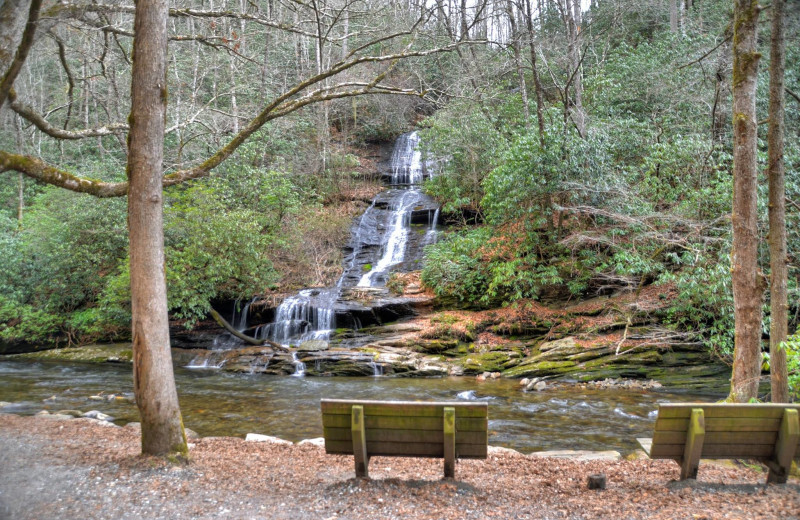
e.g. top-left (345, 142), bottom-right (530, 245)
top-left (320, 399), bottom-right (489, 478)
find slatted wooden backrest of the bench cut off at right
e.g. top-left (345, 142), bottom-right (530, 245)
top-left (650, 403), bottom-right (800, 459)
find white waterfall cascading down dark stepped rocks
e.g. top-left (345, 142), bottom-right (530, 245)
top-left (216, 132), bottom-right (439, 356)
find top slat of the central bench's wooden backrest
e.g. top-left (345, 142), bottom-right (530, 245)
top-left (320, 399), bottom-right (489, 417)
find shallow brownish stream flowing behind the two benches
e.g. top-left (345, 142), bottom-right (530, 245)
top-left (0, 361), bottom-right (720, 452)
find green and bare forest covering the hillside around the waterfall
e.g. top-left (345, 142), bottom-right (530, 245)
top-left (0, 0), bottom-right (800, 432)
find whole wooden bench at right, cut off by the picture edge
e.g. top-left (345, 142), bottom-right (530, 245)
top-left (637, 403), bottom-right (800, 484)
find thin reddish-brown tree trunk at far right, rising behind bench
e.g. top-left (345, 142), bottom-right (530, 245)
top-left (767, 0), bottom-right (789, 403)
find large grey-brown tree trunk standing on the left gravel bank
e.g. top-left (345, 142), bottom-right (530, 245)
top-left (128, 0), bottom-right (188, 455)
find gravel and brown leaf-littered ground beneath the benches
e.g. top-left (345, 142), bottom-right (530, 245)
top-left (0, 415), bottom-right (800, 520)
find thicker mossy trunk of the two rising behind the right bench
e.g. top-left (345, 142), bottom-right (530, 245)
top-left (728, 0), bottom-right (763, 402)
